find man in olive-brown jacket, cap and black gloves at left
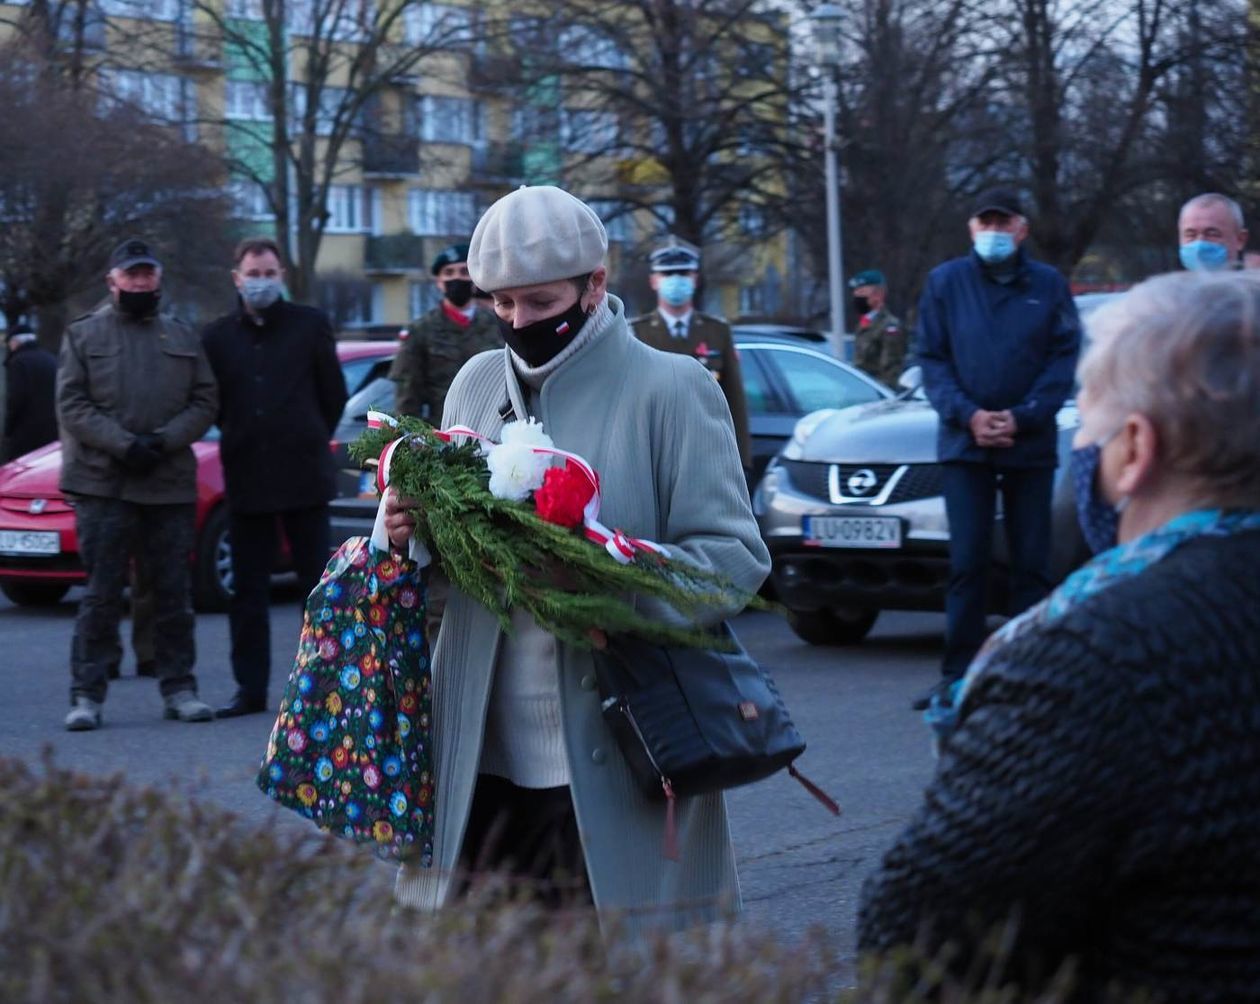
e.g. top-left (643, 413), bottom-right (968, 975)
top-left (57, 237), bottom-right (218, 732)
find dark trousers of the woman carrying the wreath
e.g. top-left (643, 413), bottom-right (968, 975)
top-left (459, 773), bottom-right (593, 908)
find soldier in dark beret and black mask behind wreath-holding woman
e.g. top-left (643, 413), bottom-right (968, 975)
top-left (389, 244), bottom-right (503, 426)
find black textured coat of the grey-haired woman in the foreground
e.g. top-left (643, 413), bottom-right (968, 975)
top-left (858, 533), bottom-right (1260, 1004)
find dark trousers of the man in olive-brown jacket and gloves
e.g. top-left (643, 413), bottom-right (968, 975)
top-left (71, 496), bottom-right (197, 702)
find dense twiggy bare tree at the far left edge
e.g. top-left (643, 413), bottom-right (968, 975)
top-left (0, 0), bottom-right (235, 349)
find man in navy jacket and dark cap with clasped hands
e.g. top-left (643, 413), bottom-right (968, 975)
top-left (915, 189), bottom-right (1081, 708)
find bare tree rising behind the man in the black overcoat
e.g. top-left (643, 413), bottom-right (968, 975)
top-left (193, 0), bottom-right (473, 299)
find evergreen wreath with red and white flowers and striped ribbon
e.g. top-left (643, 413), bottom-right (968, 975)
top-left (350, 413), bottom-right (769, 649)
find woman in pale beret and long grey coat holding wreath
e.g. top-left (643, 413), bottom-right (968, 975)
top-left (386, 185), bottom-right (770, 927)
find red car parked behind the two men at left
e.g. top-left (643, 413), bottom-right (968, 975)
top-left (0, 341), bottom-right (398, 610)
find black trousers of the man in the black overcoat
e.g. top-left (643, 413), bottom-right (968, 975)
top-left (228, 505), bottom-right (329, 699)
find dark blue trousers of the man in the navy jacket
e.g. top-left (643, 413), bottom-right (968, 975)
top-left (941, 464), bottom-right (1055, 678)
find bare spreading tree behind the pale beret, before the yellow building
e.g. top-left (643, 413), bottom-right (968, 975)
top-left (481, 0), bottom-right (798, 274)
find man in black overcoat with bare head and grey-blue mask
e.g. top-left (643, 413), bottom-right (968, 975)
top-left (202, 238), bottom-right (347, 718)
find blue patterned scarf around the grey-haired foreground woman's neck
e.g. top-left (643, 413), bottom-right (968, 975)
top-left (924, 509), bottom-right (1260, 739)
